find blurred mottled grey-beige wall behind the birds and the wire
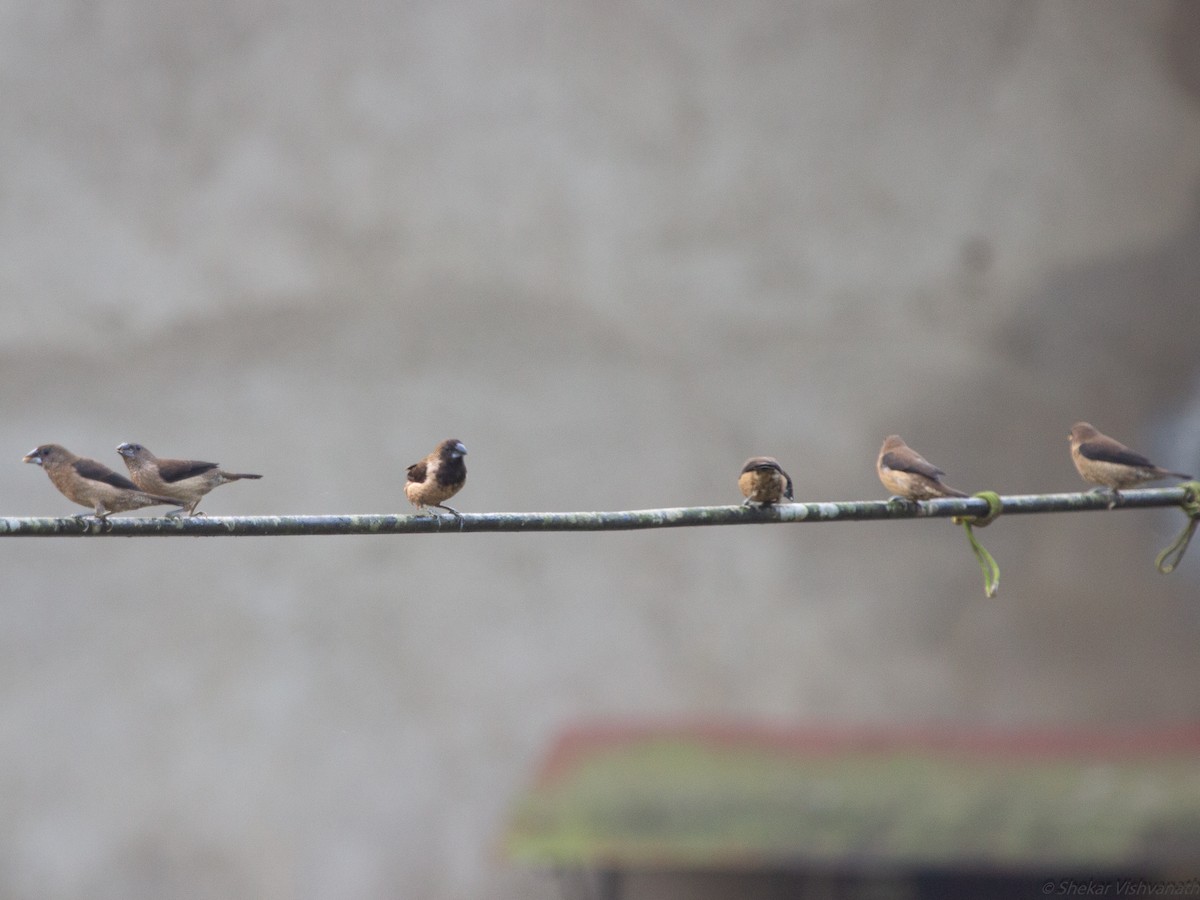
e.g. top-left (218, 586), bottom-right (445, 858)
top-left (0, 0), bottom-right (1200, 900)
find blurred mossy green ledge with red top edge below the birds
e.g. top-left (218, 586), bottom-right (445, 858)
top-left (505, 725), bottom-right (1200, 898)
